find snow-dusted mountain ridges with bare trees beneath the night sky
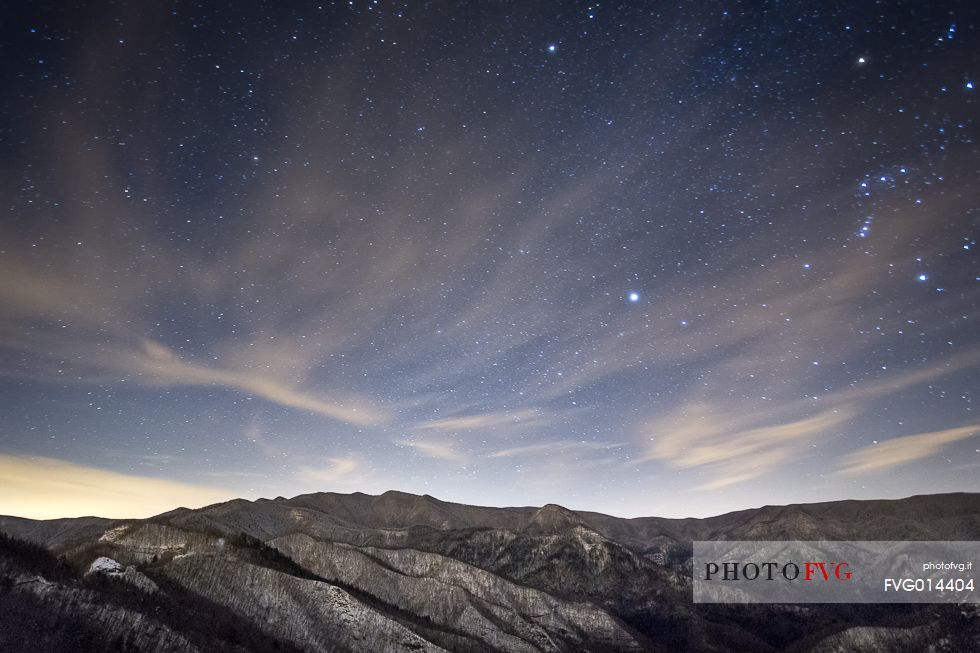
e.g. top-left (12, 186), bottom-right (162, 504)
top-left (0, 492), bottom-right (980, 653)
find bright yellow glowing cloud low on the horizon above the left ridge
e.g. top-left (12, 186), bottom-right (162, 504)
top-left (0, 454), bottom-right (240, 519)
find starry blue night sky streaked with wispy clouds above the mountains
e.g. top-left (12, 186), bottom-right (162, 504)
top-left (0, 0), bottom-right (980, 517)
